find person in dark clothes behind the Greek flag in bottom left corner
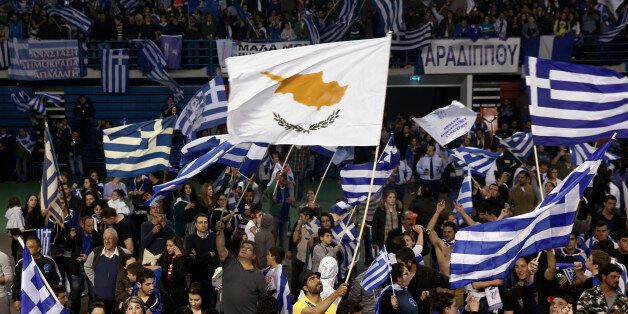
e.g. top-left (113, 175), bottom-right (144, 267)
top-left (12, 236), bottom-right (61, 311)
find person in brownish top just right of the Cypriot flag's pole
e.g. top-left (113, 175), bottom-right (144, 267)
top-left (372, 191), bottom-right (402, 252)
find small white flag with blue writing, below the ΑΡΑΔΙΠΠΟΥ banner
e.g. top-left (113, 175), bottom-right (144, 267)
top-left (412, 100), bottom-right (476, 146)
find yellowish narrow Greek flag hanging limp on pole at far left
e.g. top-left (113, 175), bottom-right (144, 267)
top-left (40, 126), bottom-right (63, 224)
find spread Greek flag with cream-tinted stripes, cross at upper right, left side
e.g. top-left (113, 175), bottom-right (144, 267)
top-left (103, 117), bottom-right (174, 178)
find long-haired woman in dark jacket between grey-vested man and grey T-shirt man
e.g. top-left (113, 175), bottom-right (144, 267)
top-left (157, 235), bottom-right (188, 306)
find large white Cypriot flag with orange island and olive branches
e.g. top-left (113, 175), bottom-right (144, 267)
top-left (226, 37), bottom-right (390, 146)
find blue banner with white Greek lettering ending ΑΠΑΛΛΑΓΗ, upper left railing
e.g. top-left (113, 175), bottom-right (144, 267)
top-left (9, 39), bottom-right (84, 81)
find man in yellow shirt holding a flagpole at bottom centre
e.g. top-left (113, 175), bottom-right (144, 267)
top-left (292, 269), bottom-right (348, 314)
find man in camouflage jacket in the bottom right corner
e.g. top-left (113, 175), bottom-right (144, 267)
top-left (575, 263), bottom-right (628, 314)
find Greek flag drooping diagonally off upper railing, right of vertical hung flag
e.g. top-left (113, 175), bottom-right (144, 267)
top-left (135, 40), bottom-right (183, 101)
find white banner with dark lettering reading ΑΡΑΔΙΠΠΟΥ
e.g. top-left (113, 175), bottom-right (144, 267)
top-left (421, 38), bottom-right (521, 74)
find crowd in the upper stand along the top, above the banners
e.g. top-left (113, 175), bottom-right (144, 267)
top-left (0, 0), bottom-right (622, 54)
